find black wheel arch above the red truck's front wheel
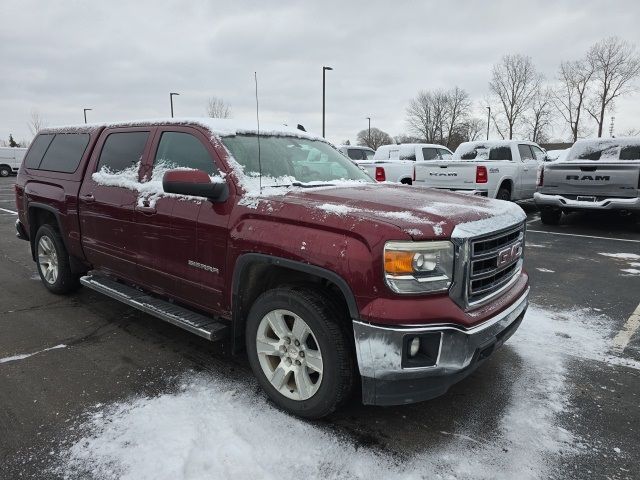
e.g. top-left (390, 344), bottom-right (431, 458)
top-left (231, 253), bottom-right (359, 352)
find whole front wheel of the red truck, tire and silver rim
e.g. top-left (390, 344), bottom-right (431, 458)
top-left (246, 287), bottom-right (354, 418)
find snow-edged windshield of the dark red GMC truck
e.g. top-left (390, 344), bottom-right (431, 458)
top-left (222, 135), bottom-right (374, 185)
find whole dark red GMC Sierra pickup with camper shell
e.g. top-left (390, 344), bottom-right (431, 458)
top-left (16, 119), bottom-right (529, 418)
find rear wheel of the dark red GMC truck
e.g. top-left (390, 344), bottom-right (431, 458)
top-left (35, 224), bottom-right (80, 295)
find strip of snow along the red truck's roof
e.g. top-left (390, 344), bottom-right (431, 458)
top-left (41, 117), bottom-right (329, 143)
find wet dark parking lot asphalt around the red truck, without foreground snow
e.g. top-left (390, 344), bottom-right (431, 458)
top-left (0, 178), bottom-right (640, 479)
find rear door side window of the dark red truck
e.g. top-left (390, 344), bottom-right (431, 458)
top-left (96, 132), bottom-right (149, 173)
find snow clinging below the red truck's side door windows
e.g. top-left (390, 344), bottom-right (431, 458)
top-left (91, 163), bottom-right (224, 207)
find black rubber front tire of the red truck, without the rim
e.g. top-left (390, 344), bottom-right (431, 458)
top-left (246, 287), bottom-right (355, 419)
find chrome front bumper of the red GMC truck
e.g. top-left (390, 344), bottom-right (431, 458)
top-left (353, 288), bottom-right (529, 405)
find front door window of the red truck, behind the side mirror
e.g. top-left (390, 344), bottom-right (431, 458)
top-left (154, 132), bottom-right (219, 175)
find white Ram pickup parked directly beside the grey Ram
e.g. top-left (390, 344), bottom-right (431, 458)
top-left (414, 140), bottom-right (546, 200)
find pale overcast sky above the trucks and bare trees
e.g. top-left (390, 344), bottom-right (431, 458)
top-left (0, 0), bottom-right (640, 143)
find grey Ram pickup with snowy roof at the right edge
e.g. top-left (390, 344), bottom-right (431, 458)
top-left (534, 137), bottom-right (640, 225)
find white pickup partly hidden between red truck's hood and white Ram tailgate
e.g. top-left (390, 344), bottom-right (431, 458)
top-left (358, 143), bottom-right (453, 185)
